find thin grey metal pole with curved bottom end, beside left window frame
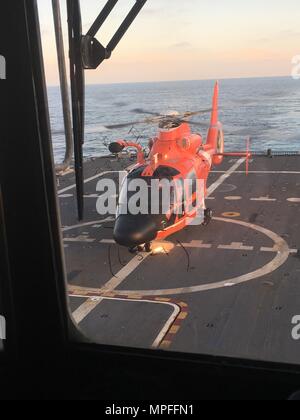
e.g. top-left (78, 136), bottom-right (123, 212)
top-left (52, 0), bottom-right (74, 172)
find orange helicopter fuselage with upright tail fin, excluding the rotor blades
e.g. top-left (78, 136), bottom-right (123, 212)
top-left (110, 83), bottom-right (251, 247)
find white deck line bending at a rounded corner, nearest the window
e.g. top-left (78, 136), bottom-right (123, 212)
top-left (70, 295), bottom-right (181, 349)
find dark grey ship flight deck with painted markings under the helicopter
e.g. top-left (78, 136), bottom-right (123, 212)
top-left (59, 157), bottom-right (300, 363)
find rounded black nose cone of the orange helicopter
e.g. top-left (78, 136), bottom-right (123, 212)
top-left (114, 215), bottom-right (158, 248)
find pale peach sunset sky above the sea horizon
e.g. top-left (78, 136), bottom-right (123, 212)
top-left (38, 0), bottom-right (300, 85)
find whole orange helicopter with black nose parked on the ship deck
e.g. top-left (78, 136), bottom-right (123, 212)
top-left (109, 83), bottom-right (251, 252)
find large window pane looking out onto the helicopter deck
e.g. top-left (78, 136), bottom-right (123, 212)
top-left (39, 0), bottom-right (300, 363)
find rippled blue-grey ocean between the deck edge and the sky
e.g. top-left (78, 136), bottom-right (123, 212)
top-left (48, 77), bottom-right (300, 162)
